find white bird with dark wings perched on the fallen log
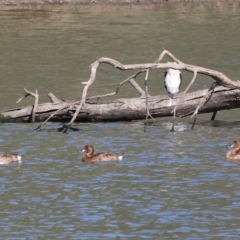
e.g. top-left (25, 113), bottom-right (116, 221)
top-left (164, 68), bottom-right (182, 107)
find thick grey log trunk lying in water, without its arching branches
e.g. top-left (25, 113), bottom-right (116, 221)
top-left (1, 86), bottom-right (240, 122)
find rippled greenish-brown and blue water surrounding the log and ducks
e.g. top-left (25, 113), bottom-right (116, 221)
top-left (0, 4), bottom-right (240, 239)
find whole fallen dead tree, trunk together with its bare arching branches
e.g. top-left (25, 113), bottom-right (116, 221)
top-left (1, 50), bottom-right (240, 132)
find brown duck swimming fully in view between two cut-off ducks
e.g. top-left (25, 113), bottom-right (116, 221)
top-left (79, 145), bottom-right (123, 163)
